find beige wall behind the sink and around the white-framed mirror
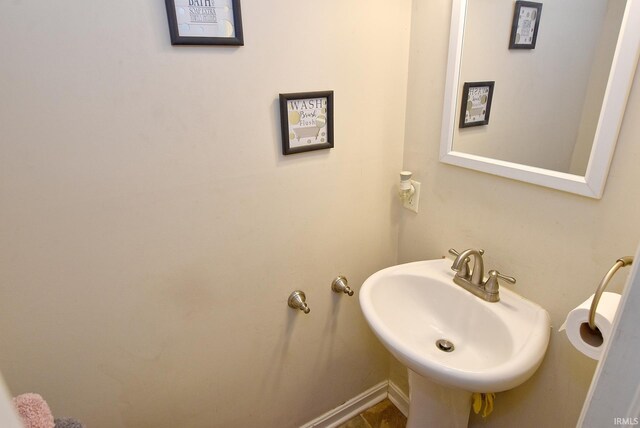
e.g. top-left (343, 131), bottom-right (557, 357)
top-left (400, 1), bottom-right (640, 427)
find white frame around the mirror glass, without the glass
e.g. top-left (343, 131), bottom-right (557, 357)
top-left (440, 0), bottom-right (640, 199)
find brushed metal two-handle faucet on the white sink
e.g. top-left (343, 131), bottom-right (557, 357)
top-left (449, 248), bottom-right (516, 302)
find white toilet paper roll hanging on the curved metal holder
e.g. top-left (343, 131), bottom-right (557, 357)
top-left (559, 293), bottom-right (620, 360)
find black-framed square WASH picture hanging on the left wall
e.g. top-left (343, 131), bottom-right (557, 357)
top-left (280, 91), bottom-right (334, 155)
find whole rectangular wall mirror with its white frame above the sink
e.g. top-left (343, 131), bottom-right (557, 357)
top-left (440, 0), bottom-right (640, 198)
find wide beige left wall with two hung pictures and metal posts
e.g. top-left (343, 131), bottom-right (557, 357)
top-left (0, 0), bottom-right (411, 428)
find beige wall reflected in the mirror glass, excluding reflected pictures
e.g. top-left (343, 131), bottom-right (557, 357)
top-left (453, 0), bottom-right (625, 175)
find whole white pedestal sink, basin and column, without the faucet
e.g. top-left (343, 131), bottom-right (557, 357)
top-left (360, 259), bottom-right (551, 428)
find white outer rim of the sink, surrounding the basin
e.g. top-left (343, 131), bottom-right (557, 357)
top-left (359, 259), bottom-right (551, 392)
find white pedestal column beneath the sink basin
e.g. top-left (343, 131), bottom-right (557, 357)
top-left (407, 369), bottom-right (471, 428)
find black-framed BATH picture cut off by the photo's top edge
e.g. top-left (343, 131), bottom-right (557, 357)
top-left (165, 0), bottom-right (244, 46)
